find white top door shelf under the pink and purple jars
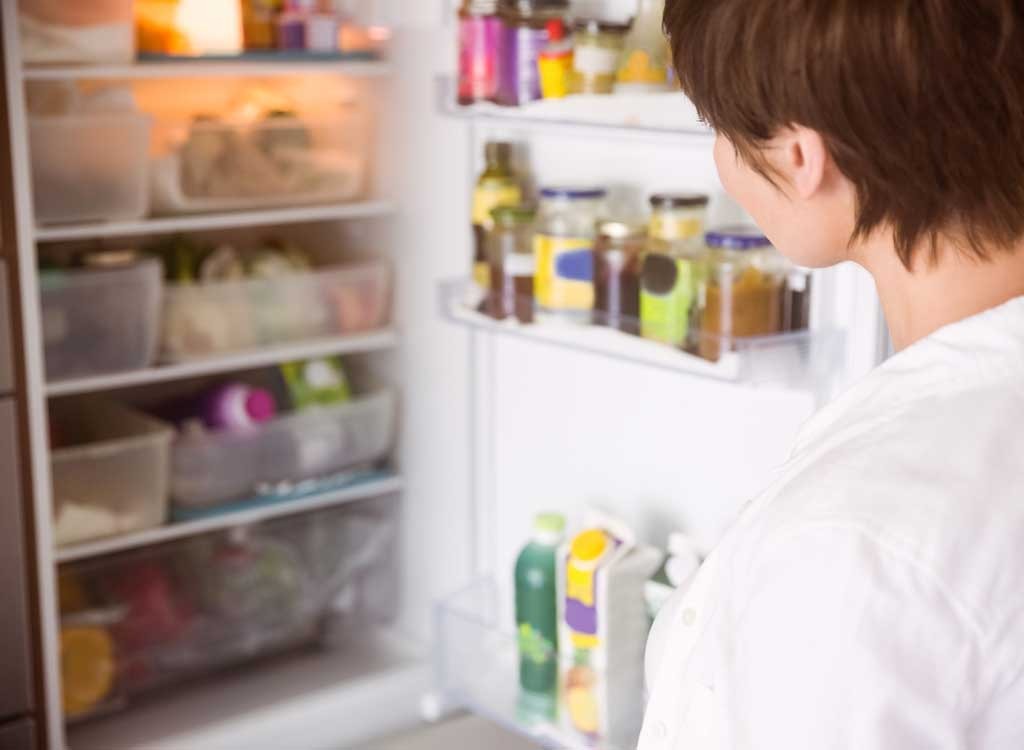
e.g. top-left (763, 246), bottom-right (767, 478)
top-left (437, 77), bottom-right (714, 147)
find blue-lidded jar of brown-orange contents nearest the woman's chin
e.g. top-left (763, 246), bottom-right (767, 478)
top-left (698, 226), bottom-right (786, 362)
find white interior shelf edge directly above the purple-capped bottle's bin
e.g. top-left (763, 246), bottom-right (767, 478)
top-left (46, 328), bottom-right (398, 397)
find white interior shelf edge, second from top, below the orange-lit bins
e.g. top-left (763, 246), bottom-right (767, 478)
top-left (35, 201), bottom-right (395, 242)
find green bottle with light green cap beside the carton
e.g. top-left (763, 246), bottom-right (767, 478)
top-left (515, 513), bottom-right (565, 694)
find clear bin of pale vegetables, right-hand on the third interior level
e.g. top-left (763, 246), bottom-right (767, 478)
top-left (162, 262), bottom-right (390, 362)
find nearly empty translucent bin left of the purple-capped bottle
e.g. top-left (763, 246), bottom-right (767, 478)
top-left (50, 400), bottom-right (174, 546)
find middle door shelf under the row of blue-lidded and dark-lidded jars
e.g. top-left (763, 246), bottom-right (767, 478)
top-left (440, 279), bottom-right (844, 393)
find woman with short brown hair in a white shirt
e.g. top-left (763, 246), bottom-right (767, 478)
top-left (640, 0), bottom-right (1024, 750)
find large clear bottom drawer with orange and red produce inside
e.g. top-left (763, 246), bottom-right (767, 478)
top-left (59, 498), bottom-right (396, 720)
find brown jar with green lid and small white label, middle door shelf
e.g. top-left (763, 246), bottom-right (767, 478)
top-left (486, 206), bottom-right (537, 323)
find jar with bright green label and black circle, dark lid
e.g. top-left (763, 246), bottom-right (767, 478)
top-left (640, 193), bottom-right (708, 350)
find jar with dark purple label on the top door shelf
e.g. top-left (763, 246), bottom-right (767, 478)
top-left (498, 0), bottom-right (569, 107)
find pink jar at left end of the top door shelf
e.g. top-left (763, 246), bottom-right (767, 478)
top-left (459, 0), bottom-right (502, 105)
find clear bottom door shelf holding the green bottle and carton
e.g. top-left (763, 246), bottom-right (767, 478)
top-left (436, 579), bottom-right (642, 750)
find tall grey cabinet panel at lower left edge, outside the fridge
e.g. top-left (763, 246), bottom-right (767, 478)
top-left (0, 399), bottom-right (32, 721)
